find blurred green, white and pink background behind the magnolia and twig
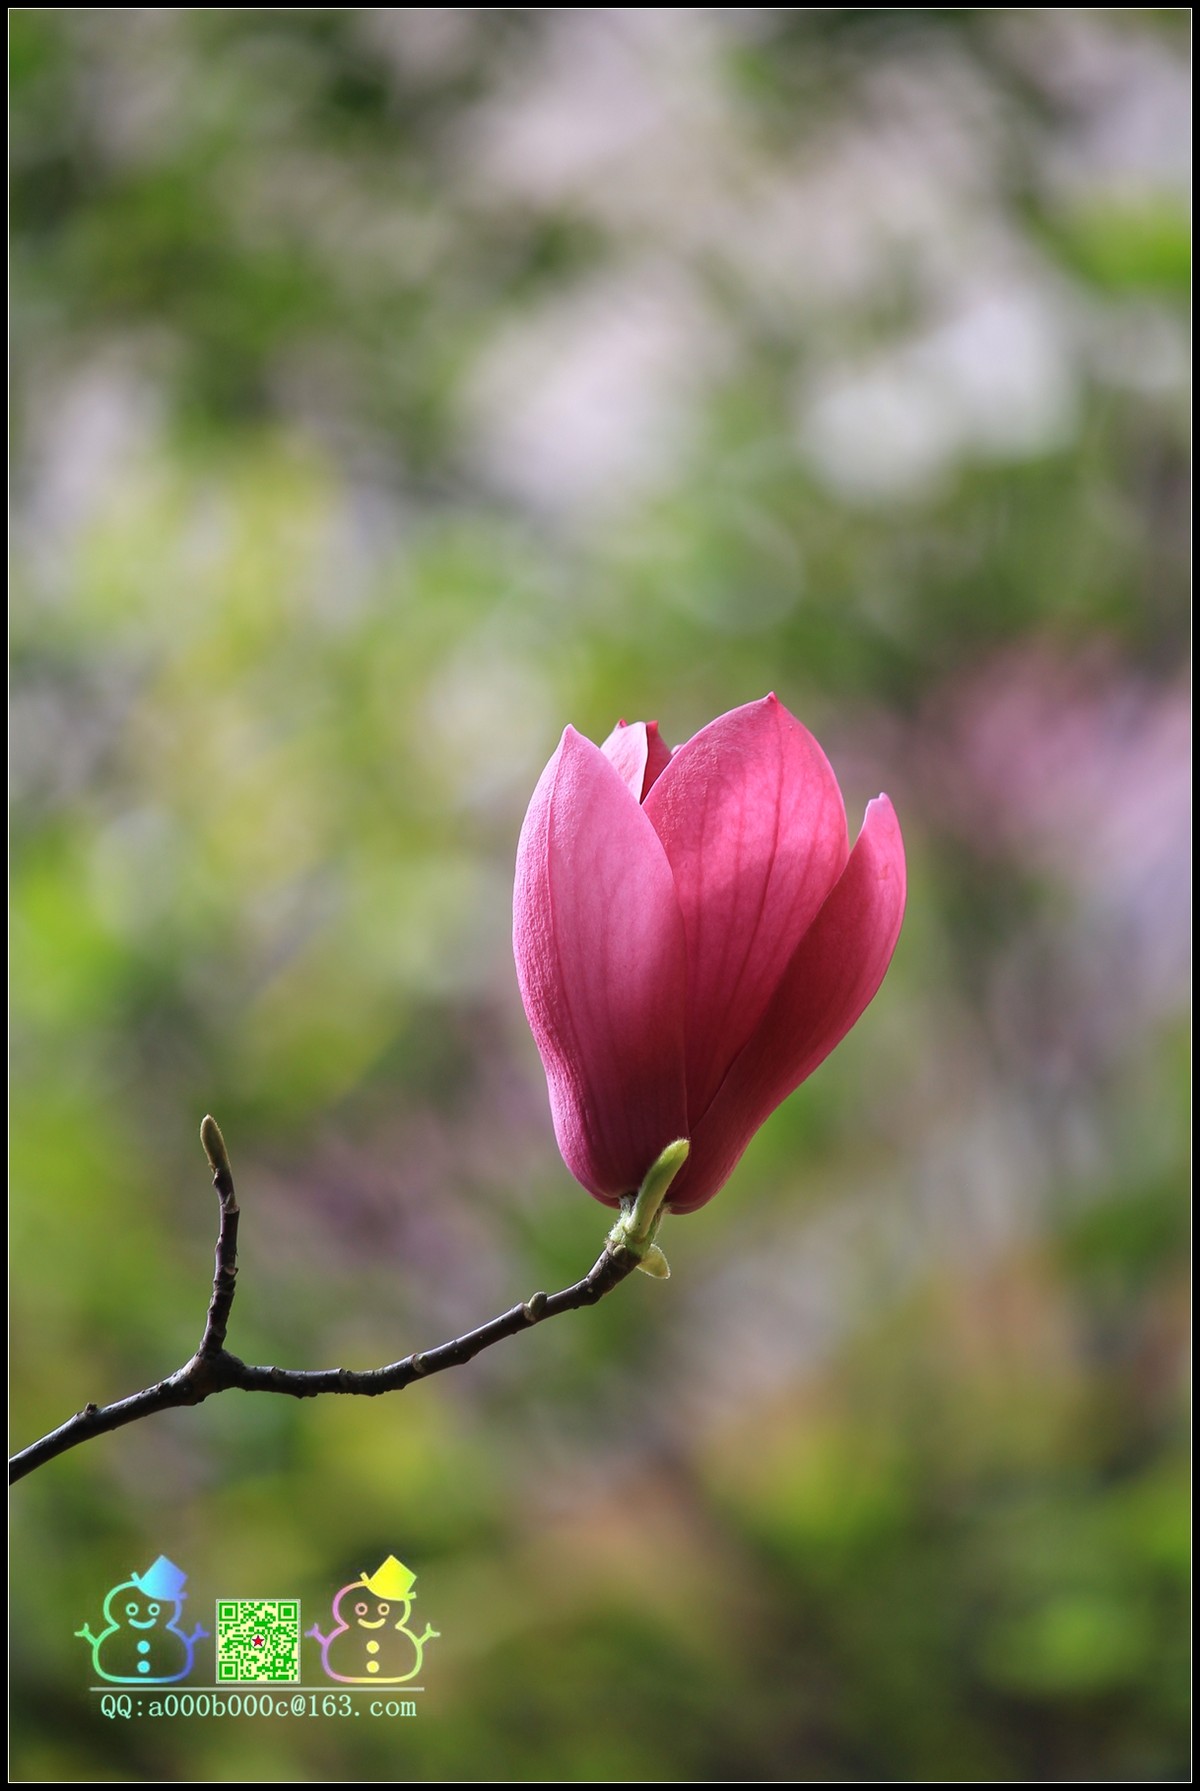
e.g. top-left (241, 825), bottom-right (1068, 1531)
top-left (11, 7), bottom-right (1189, 1782)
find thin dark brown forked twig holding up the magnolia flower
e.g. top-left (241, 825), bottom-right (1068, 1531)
top-left (9, 1116), bottom-right (651, 1485)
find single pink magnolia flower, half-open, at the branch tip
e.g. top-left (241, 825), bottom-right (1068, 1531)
top-left (512, 695), bottom-right (904, 1213)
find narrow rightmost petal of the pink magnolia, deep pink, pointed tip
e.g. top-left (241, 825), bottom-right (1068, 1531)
top-left (668, 795), bottom-right (906, 1213)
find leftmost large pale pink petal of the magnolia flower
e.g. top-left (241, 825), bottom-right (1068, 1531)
top-left (512, 727), bottom-right (686, 1205)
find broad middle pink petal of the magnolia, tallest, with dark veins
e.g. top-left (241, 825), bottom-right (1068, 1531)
top-left (645, 695), bottom-right (849, 1124)
